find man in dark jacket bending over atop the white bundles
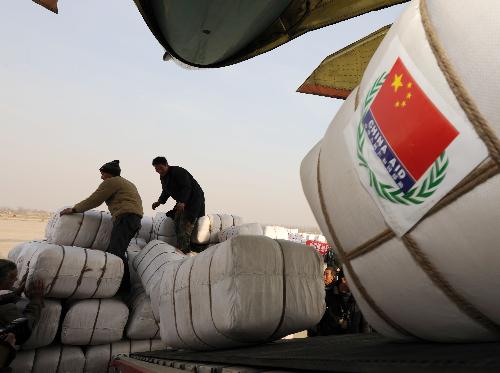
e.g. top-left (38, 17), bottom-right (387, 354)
top-left (151, 157), bottom-right (205, 253)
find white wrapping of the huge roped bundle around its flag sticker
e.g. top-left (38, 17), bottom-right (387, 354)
top-left (301, 0), bottom-right (500, 342)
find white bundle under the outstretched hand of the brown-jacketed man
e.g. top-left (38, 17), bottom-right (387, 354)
top-left (46, 210), bottom-right (113, 251)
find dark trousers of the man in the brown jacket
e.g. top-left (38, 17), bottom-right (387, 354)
top-left (107, 214), bottom-right (142, 292)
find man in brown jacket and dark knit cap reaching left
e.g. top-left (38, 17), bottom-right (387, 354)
top-left (61, 160), bottom-right (144, 290)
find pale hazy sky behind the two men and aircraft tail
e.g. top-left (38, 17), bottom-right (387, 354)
top-left (0, 0), bottom-right (403, 226)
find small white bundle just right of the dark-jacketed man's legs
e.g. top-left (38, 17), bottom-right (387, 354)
top-left (191, 214), bottom-right (243, 245)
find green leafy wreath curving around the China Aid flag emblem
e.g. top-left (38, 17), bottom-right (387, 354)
top-left (357, 72), bottom-right (448, 205)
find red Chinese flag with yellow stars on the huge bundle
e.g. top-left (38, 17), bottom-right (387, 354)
top-left (370, 58), bottom-right (458, 181)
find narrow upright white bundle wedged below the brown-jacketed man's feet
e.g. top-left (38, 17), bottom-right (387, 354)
top-left (125, 286), bottom-right (160, 339)
